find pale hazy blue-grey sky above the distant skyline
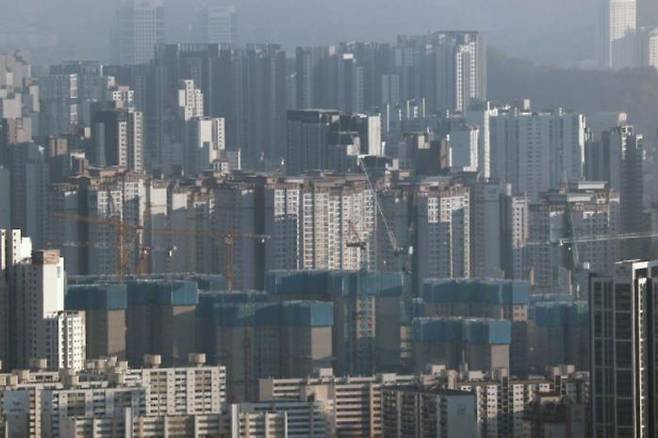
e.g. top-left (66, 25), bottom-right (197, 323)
top-left (0, 0), bottom-right (596, 64)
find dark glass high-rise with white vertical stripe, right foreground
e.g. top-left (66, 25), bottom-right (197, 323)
top-left (590, 261), bottom-right (658, 437)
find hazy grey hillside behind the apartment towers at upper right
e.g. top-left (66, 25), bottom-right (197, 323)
top-left (488, 49), bottom-right (658, 142)
